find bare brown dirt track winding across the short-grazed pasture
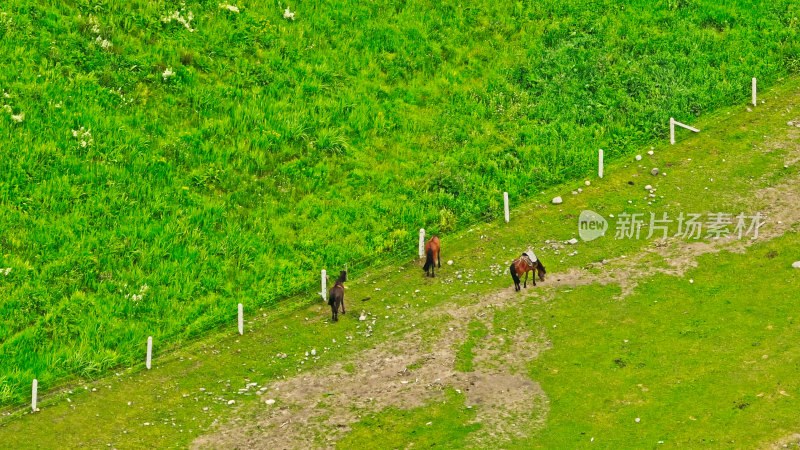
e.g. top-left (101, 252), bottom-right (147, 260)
top-left (194, 130), bottom-right (800, 449)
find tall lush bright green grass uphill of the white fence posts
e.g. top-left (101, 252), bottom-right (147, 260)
top-left (0, 0), bottom-right (800, 404)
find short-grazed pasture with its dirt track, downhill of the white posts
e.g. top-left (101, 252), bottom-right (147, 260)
top-left (0, 73), bottom-right (800, 449)
